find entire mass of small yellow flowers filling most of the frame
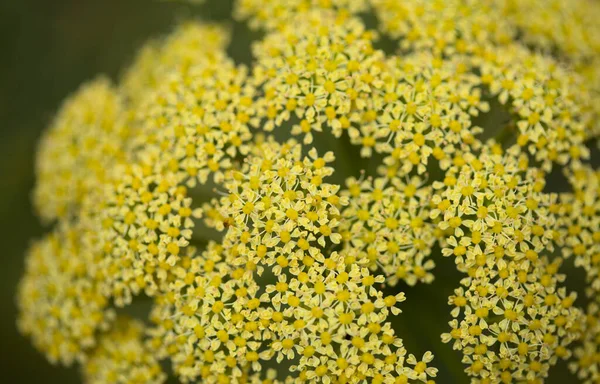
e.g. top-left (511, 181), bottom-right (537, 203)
top-left (18, 0), bottom-right (600, 384)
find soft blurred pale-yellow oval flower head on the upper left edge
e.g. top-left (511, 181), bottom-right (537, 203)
top-left (34, 77), bottom-right (133, 221)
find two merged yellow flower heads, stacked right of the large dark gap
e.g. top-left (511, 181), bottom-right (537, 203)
top-left (432, 148), bottom-right (581, 382)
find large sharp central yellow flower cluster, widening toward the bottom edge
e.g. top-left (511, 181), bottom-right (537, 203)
top-left (177, 140), bottom-right (436, 382)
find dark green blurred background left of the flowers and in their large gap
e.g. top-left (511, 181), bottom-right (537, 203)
top-left (0, 0), bottom-right (592, 383)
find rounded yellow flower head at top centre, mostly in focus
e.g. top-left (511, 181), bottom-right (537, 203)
top-left (253, 11), bottom-right (383, 144)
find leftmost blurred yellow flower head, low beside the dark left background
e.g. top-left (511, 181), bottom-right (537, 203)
top-left (18, 223), bottom-right (114, 364)
